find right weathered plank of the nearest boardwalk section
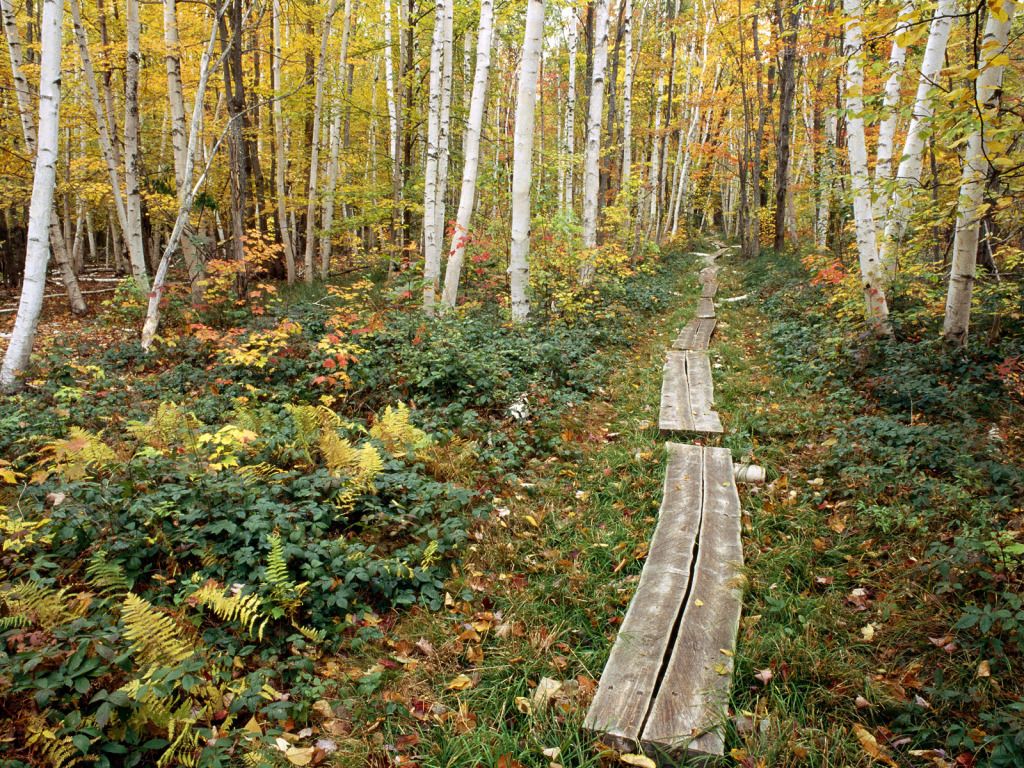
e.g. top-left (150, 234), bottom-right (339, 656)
top-left (641, 447), bottom-right (743, 756)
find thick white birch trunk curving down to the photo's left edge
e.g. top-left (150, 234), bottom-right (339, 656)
top-left (0, 0), bottom-right (63, 392)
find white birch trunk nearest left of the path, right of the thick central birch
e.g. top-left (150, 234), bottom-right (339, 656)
top-left (580, 0), bottom-right (608, 286)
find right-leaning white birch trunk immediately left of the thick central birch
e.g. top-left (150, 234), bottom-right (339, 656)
top-left (441, 0), bottom-right (495, 307)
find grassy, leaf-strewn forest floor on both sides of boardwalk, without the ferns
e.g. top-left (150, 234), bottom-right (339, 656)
top-left (0, 247), bottom-right (1024, 768)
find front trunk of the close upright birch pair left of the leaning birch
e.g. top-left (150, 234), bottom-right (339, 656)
top-left (423, 0), bottom-right (444, 314)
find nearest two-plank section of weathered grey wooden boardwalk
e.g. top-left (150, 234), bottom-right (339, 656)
top-left (584, 442), bottom-right (742, 755)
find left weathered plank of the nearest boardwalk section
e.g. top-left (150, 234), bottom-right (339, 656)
top-left (584, 442), bottom-right (703, 752)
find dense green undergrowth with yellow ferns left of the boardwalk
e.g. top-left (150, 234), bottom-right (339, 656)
top-left (0, 246), bottom-right (681, 766)
